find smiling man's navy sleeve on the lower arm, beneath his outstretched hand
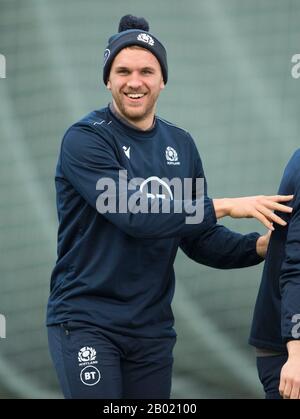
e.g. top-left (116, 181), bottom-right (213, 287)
top-left (180, 136), bottom-right (264, 269)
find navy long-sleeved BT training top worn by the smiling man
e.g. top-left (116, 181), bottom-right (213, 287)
top-left (47, 107), bottom-right (261, 337)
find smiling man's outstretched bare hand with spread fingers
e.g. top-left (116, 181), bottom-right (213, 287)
top-left (213, 195), bottom-right (293, 231)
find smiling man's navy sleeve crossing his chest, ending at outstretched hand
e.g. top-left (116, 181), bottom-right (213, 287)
top-left (60, 125), bottom-right (216, 239)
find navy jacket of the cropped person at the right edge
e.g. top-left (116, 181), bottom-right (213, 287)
top-left (249, 150), bottom-right (300, 352)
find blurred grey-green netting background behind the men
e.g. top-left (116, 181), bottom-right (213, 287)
top-left (0, 0), bottom-right (300, 398)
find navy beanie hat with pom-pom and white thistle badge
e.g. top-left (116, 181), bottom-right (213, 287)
top-left (103, 15), bottom-right (168, 84)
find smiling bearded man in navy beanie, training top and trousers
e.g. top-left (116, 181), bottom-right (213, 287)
top-left (47, 16), bottom-right (289, 398)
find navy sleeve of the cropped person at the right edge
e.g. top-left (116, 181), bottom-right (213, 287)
top-left (280, 195), bottom-right (300, 342)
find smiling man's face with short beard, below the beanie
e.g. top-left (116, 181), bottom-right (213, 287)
top-left (107, 47), bottom-right (164, 129)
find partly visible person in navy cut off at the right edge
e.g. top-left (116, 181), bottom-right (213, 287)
top-left (249, 150), bottom-right (300, 399)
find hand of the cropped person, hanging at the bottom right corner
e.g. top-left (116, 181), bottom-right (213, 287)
top-left (279, 340), bottom-right (300, 399)
